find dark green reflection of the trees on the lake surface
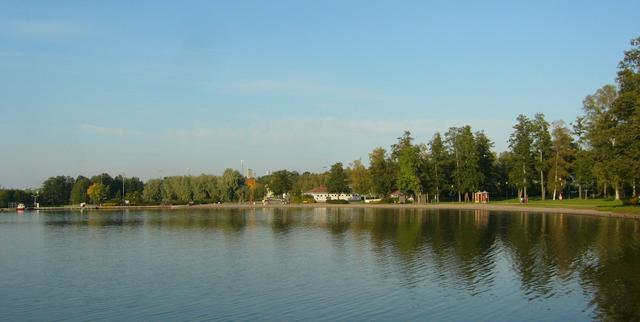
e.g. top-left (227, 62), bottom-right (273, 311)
top-left (46, 208), bottom-right (640, 321)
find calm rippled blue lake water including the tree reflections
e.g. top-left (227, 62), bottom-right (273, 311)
top-left (0, 209), bottom-right (640, 321)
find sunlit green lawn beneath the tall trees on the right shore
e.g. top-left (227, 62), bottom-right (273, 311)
top-left (492, 199), bottom-right (640, 215)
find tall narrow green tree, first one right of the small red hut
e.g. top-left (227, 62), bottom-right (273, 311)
top-left (509, 114), bottom-right (533, 199)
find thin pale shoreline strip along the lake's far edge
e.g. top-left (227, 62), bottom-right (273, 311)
top-left (0, 202), bottom-right (640, 220)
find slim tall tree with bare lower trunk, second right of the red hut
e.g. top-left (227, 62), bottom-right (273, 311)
top-left (531, 113), bottom-right (551, 200)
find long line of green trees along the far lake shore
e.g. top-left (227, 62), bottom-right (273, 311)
top-left (0, 38), bottom-right (640, 207)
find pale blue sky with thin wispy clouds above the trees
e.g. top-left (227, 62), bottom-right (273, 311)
top-left (0, 0), bottom-right (640, 187)
